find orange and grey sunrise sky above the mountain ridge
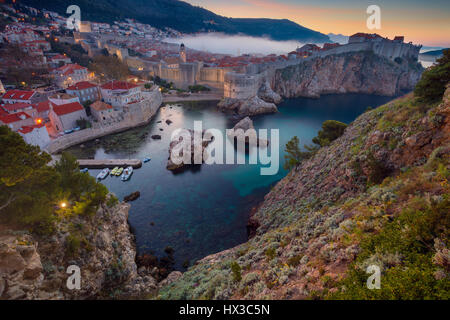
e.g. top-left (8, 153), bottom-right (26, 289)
top-left (185, 0), bottom-right (450, 47)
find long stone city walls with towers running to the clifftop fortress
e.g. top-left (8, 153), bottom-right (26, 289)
top-left (75, 33), bottom-right (421, 100)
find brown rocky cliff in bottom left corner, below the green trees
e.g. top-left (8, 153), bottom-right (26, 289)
top-left (0, 203), bottom-right (157, 299)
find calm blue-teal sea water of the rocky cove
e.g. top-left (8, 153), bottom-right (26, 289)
top-left (69, 94), bottom-right (392, 269)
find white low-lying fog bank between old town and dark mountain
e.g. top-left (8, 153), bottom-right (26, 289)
top-left (165, 33), bottom-right (310, 56)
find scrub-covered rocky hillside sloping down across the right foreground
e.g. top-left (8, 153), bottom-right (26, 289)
top-left (159, 85), bottom-right (450, 299)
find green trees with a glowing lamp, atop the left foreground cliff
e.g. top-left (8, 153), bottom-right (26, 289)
top-left (0, 126), bottom-right (108, 234)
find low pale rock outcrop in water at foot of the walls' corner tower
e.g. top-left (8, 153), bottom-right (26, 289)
top-left (217, 96), bottom-right (278, 116)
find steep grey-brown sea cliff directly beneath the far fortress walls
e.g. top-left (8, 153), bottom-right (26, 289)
top-left (272, 51), bottom-right (423, 98)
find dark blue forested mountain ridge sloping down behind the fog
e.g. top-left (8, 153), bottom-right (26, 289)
top-left (20, 0), bottom-right (329, 42)
